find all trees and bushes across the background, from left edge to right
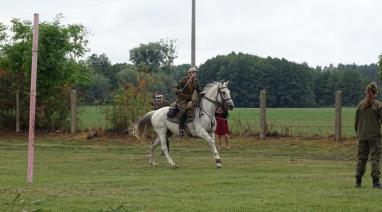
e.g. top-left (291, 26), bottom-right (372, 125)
top-left (0, 16), bottom-right (382, 130)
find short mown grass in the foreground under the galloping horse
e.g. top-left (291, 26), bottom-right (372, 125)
top-left (0, 136), bottom-right (382, 211)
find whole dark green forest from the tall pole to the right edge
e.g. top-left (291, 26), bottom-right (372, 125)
top-left (199, 52), bottom-right (379, 107)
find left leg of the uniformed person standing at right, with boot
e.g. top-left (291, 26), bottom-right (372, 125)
top-left (355, 140), bottom-right (369, 187)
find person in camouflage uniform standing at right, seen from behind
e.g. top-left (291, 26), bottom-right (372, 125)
top-left (354, 82), bottom-right (382, 189)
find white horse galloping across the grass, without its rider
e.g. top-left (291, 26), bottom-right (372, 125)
top-left (136, 82), bottom-right (234, 168)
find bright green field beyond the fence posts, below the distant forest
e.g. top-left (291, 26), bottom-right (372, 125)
top-left (79, 106), bottom-right (355, 137)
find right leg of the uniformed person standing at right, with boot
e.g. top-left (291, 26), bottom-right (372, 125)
top-left (370, 139), bottom-right (381, 188)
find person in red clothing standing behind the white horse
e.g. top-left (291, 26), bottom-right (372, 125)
top-left (215, 106), bottom-right (230, 150)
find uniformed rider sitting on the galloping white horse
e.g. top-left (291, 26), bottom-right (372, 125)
top-left (176, 67), bottom-right (200, 136)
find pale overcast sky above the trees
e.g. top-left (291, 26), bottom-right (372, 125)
top-left (0, 0), bottom-right (382, 66)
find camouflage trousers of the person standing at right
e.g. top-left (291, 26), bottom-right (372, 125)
top-left (355, 138), bottom-right (381, 178)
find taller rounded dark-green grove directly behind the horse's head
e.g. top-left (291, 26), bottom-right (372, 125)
top-left (199, 53), bottom-right (315, 107)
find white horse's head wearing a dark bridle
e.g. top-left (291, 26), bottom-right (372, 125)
top-left (205, 81), bottom-right (234, 110)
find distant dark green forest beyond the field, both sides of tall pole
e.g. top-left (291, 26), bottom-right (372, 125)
top-left (77, 53), bottom-right (381, 107)
